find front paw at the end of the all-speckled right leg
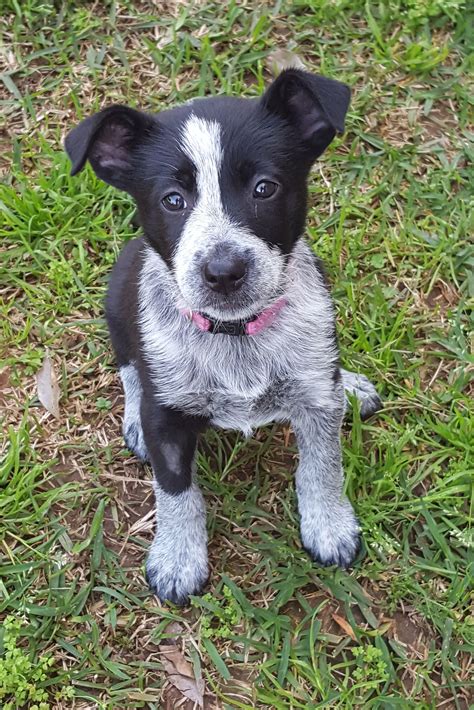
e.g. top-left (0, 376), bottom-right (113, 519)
top-left (301, 502), bottom-right (360, 569)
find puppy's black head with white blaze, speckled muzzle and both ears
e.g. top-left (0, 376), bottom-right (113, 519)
top-left (66, 70), bottom-right (350, 320)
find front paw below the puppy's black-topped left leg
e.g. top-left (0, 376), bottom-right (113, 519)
top-left (146, 544), bottom-right (209, 606)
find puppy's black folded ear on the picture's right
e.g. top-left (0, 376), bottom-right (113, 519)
top-left (262, 69), bottom-right (351, 160)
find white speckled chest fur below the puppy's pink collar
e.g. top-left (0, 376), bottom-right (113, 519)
top-left (139, 241), bottom-right (342, 434)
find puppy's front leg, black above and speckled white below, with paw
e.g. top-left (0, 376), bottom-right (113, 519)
top-left (141, 396), bottom-right (209, 604)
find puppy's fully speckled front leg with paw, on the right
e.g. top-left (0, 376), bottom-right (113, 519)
top-left (291, 404), bottom-right (360, 567)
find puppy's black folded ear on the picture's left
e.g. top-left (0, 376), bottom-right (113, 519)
top-left (64, 106), bottom-right (157, 192)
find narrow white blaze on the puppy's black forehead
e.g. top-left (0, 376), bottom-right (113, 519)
top-left (181, 114), bottom-right (223, 209)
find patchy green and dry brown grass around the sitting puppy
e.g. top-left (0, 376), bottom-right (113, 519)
top-left (0, 0), bottom-right (474, 709)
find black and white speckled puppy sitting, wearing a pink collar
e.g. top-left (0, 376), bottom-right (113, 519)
top-left (66, 69), bottom-right (380, 603)
